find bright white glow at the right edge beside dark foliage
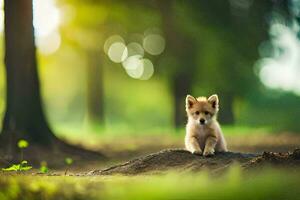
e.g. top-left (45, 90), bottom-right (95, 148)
top-left (257, 23), bottom-right (300, 94)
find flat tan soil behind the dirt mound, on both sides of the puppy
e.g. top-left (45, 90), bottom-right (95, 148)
top-left (0, 130), bottom-right (300, 174)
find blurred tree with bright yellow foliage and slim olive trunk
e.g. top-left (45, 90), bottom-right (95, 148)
top-left (60, 1), bottom-right (107, 128)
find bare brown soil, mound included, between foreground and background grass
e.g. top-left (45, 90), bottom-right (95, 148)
top-left (0, 134), bottom-right (300, 175)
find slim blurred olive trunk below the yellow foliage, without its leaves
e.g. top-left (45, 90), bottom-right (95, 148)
top-left (87, 50), bottom-right (104, 125)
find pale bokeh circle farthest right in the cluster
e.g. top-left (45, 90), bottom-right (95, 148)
top-left (143, 34), bottom-right (165, 55)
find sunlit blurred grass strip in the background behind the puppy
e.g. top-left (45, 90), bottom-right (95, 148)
top-left (49, 124), bottom-right (273, 151)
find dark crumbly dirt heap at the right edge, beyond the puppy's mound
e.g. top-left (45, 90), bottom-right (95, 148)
top-left (243, 149), bottom-right (300, 169)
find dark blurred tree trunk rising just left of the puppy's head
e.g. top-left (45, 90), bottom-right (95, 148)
top-left (158, 0), bottom-right (196, 128)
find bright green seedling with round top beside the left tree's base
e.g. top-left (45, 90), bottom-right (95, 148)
top-left (2, 140), bottom-right (32, 172)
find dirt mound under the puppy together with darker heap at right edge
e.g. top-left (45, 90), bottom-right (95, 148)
top-left (89, 149), bottom-right (300, 175)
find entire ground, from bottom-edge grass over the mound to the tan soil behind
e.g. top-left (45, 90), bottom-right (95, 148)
top-left (0, 130), bottom-right (300, 199)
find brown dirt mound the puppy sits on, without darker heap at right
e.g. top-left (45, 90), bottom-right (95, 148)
top-left (88, 149), bottom-right (257, 175)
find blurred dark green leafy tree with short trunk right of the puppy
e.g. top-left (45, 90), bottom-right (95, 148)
top-left (184, 0), bottom-right (272, 124)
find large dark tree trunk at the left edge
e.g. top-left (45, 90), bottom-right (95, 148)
top-left (1, 0), bottom-right (56, 145)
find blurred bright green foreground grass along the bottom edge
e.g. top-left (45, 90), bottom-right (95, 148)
top-left (0, 167), bottom-right (300, 200)
